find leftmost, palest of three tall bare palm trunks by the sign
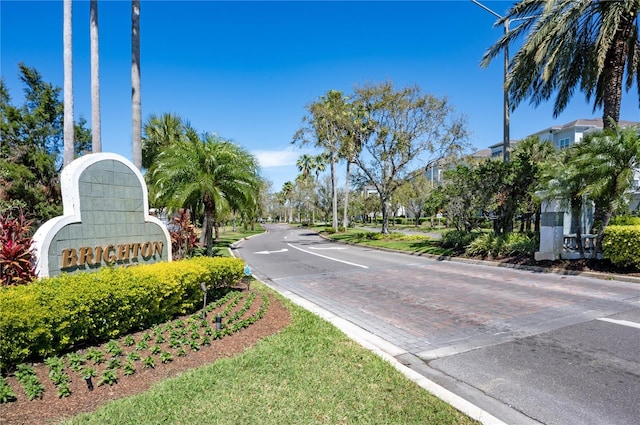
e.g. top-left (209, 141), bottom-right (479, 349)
top-left (62, 0), bottom-right (74, 167)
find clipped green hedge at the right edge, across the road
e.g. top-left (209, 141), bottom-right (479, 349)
top-left (602, 226), bottom-right (640, 268)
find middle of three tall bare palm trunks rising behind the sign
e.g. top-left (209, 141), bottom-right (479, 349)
top-left (89, 0), bottom-right (102, 153)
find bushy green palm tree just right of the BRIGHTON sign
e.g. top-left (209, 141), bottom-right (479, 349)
top-left (149, 134), bottom-right (260, 255)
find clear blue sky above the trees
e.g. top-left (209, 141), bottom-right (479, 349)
top-left (0, 0), bottom-right (640, 191)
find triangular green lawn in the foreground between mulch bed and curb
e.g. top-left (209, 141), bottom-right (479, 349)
top-left (64, 283), bottom-right (477, 425)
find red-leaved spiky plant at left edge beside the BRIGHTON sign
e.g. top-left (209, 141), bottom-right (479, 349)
top-left (0, 210), bottom-right (36, 286)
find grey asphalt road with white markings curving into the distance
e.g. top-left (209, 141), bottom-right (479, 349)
top-left (236, 225), bottom-right (640, 425)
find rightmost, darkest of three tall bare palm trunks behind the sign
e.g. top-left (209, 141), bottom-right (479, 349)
top-left (131, 0), bottom-right (142, 168)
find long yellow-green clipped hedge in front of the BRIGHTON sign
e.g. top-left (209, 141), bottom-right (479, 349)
top-left (0, 257), bottom-right (244, 371)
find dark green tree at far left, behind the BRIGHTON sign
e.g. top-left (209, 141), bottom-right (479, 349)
top-left (0, 63), bottom-right (91, 227)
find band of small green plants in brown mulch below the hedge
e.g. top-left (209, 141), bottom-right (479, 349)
top-left (0, 291), bottom-right (269, 403)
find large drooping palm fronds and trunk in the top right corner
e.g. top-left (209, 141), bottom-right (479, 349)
top-left (482, 0), bottom-right (640, 128)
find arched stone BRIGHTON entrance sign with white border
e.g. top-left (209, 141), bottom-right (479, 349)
top-left (34, 153), bottom-right (171, 277)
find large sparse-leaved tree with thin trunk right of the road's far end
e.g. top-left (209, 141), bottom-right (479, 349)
top-left (353, 82), bottom-right (468, 233)
